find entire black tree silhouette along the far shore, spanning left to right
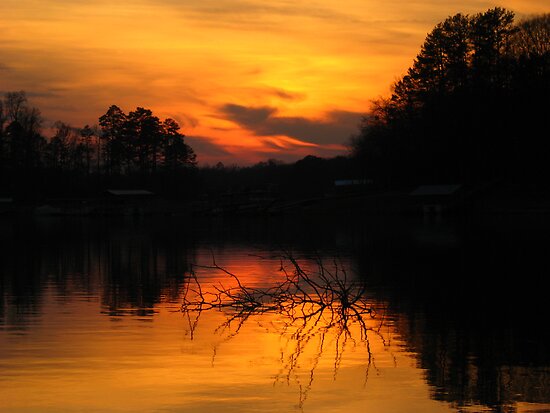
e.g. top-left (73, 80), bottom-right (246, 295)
top-left (0, 7), bottom-right (550, 204)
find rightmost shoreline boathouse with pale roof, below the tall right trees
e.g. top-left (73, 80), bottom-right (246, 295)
top-left (409, 184), bottom-right (462, 214)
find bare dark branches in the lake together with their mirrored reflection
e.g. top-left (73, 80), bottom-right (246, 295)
top-left (181, 252), bottom-right (389, 408)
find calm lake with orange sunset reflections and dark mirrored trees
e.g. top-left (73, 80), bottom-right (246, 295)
top-left (0, 217), bottom-right (550, 413)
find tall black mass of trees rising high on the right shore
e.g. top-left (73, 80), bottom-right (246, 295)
top-left (352, 7), bottom-right (550, 187)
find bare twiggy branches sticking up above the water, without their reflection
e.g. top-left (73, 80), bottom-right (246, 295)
top-left (182, 254), bottom-right (373, 321)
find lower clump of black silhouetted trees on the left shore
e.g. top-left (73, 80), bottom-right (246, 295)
top-left (0, 96), bottom-right (197, 198)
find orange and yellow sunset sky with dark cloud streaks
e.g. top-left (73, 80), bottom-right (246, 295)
top-left (0, 0), bottom-right (550, 164)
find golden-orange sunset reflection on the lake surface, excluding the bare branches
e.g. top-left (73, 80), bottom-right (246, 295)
top-left (0, 249), bottom-right (453, 412)
